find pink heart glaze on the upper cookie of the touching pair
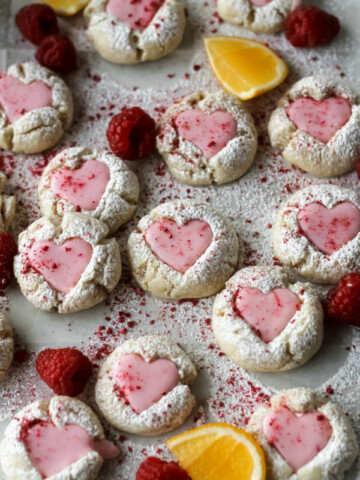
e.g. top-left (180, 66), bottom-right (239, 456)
top-left (50, 160), bottom-right (110, 210)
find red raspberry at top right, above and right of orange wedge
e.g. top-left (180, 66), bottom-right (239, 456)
top-left (285, 6), bottom-right (340, 47)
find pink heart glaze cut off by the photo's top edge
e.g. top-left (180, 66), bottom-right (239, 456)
top-left (106, 0), bottom-right (164, 32)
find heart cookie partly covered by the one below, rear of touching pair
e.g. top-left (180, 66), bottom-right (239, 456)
top-left (39, 147), bottom-right (139, 232)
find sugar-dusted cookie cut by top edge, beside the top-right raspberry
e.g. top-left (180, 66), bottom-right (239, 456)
top-left (218, 0), bottom-right (299, 33)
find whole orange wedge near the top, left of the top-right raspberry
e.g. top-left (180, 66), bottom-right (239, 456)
top-left (204, 35), bottom-right (288, 100)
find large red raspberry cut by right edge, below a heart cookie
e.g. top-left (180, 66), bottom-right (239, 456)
top-left (323, 273), bottom-right (360, 327)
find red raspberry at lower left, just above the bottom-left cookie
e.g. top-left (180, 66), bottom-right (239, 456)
top-left (36, 347), bottom-right (92, 397)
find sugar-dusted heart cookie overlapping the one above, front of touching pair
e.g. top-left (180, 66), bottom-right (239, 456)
top-left (14, 213), bottom-right (121, 313)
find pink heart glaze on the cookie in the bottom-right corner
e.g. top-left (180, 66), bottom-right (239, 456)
top-left (262, 407), bottom-right (332, 472)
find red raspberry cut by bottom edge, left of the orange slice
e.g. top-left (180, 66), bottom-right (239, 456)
top-left (136, 457), bottom-right (190, 480)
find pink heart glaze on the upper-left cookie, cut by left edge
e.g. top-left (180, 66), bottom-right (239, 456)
top-left (0, 72), bottom-right (52, 123)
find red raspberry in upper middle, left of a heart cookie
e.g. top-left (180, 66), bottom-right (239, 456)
top-left (106, 107), bottom-right (156, 160)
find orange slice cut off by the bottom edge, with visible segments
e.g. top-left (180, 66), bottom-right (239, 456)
top-left (166, 423), bottom-right (266, 480)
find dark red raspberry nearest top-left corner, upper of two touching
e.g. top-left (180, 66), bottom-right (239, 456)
top-left (15, 3), bottom-right (59, 45)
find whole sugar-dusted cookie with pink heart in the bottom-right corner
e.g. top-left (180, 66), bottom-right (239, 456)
top-left (247, 388), bottom-right (358, 480)
